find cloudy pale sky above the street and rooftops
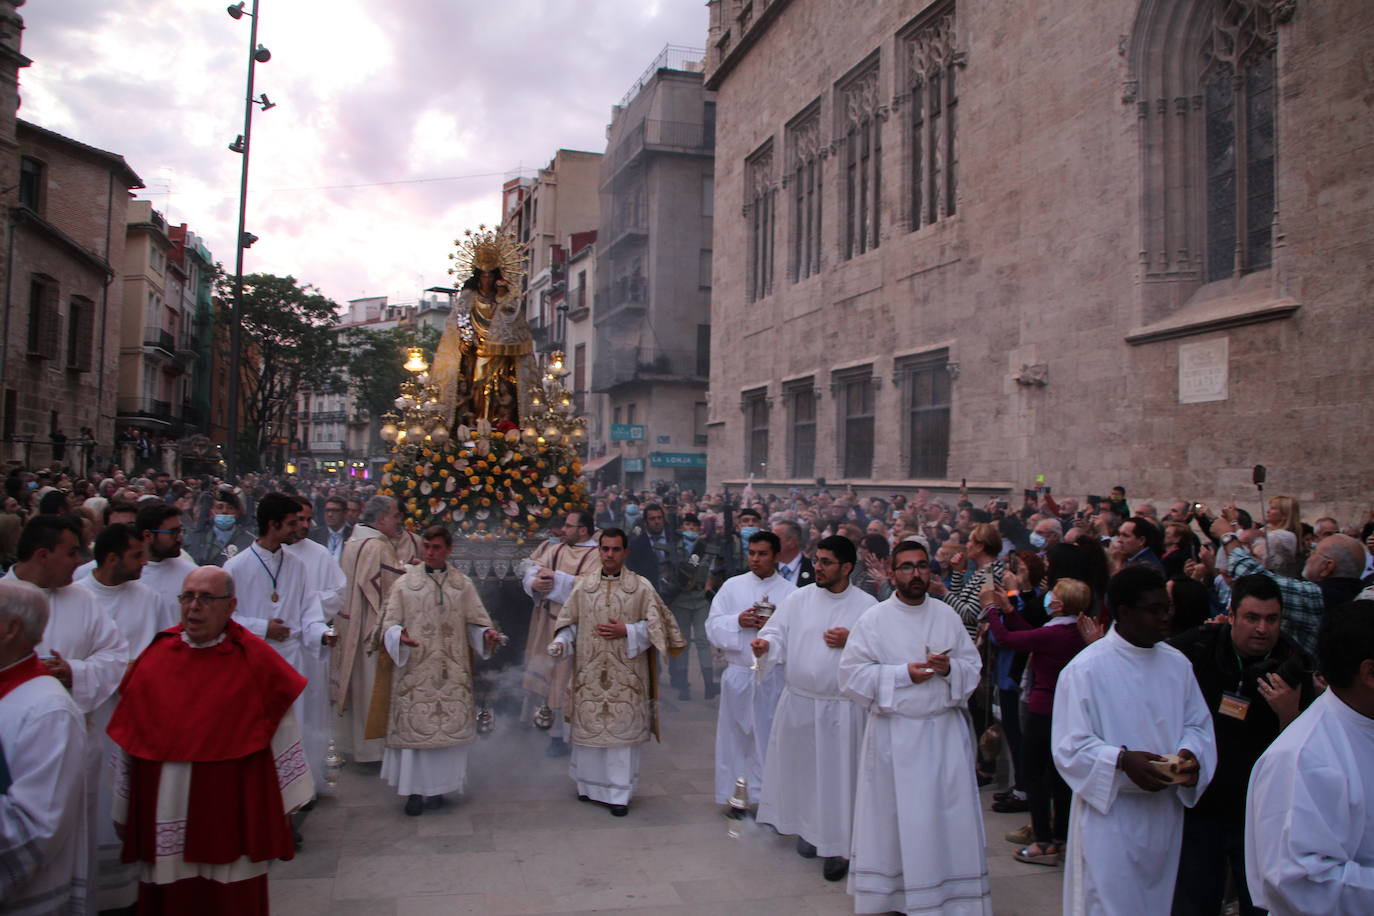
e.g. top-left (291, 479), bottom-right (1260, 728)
top-left (19, 0), bottom-right (706, 304)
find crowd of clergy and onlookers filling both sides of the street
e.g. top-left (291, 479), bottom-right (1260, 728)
top-left (0, 467), bottom-right (1374, 915)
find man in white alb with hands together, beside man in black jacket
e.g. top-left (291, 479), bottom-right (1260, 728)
top-left (1050, 566), bottom-right (1216, 916)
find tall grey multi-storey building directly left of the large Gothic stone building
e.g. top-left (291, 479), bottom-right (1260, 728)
top-left (591, 47), bottom-right (717, 490)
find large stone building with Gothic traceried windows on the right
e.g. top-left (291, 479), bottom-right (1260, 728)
top-left (706, 0), bottom-right (1374, 520)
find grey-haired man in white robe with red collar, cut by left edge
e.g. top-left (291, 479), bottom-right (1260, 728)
top-left (0, 580), bottom-right (87, 913)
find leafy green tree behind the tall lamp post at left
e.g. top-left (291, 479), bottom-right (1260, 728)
top-left (221, 273), bottom-right (345, 470)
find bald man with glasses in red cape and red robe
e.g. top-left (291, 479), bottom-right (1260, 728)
top-left (109, 566), bottom-right (315, 916)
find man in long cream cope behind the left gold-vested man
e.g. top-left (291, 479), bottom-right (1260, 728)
top-left (330, 496), bottom-right (420, 764)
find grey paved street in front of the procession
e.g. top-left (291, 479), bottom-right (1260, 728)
top-left (271, 678), bottom-right (1061, 916)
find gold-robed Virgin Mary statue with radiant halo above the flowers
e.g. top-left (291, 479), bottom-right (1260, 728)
top-left (430, 227), bottom-right (539, 430)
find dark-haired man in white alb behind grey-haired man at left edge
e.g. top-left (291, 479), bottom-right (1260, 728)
top-left (5, 515), bottom-right (129, 904)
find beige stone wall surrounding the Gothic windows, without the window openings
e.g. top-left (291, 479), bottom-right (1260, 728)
top-left (708, 0), bottom-right (1374, 520)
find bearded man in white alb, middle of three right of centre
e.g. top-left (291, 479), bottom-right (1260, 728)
top-left (750, 536), bottom-right (874, 882)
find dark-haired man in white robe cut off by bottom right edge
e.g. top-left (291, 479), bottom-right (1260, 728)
top-left (1245, 600), bottom-right (1374, 916)
